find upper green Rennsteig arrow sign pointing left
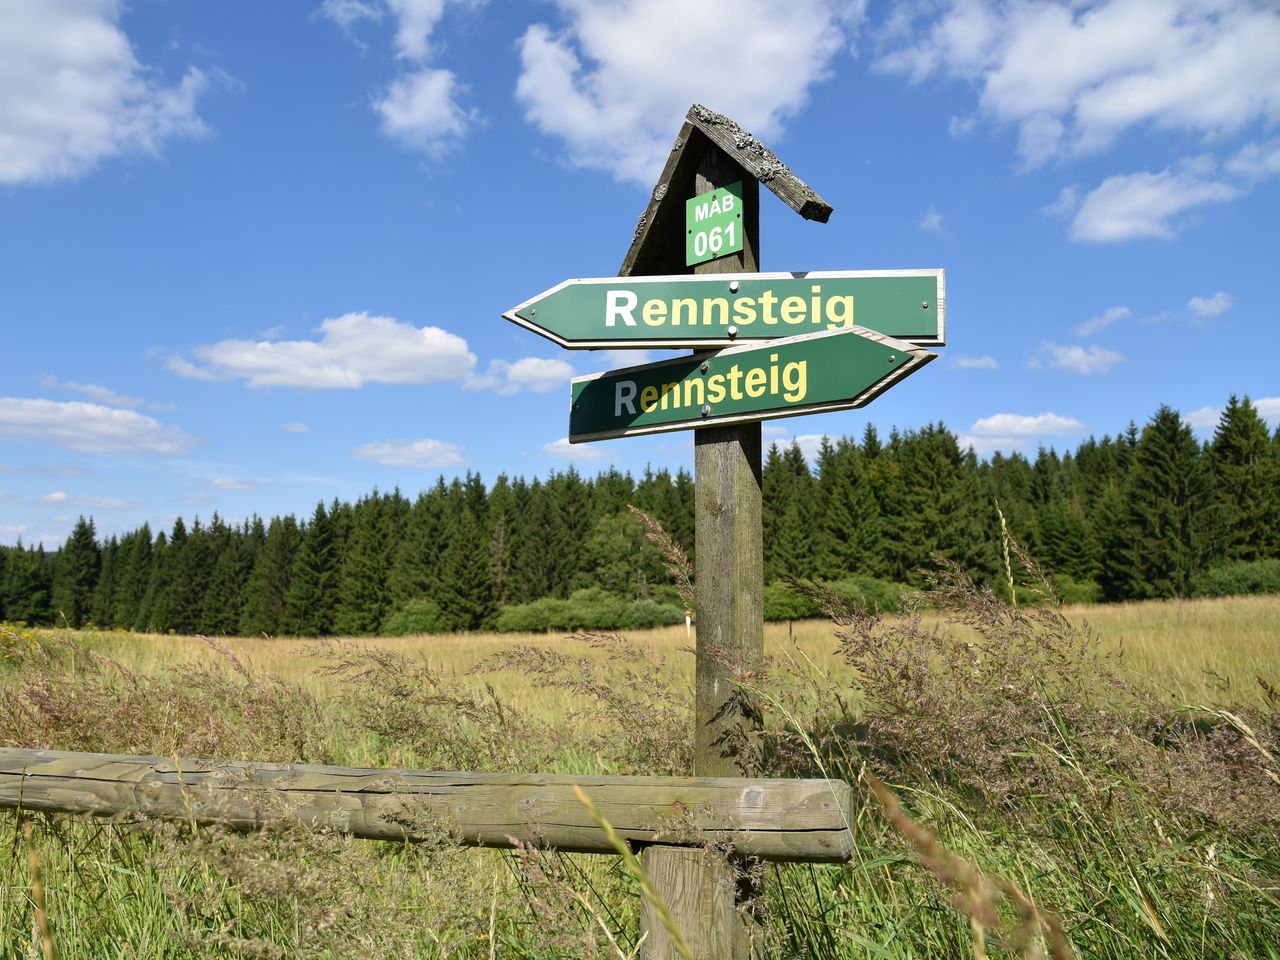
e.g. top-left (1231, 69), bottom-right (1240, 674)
top-left (503, 270), bottom-right (946, 349)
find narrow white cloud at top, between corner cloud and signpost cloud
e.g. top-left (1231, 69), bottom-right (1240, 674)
top-left (319, 0), bottom-right (483, 157)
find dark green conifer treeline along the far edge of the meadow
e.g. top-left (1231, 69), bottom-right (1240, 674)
top-left (0, 397), bottom-right (1280, 635)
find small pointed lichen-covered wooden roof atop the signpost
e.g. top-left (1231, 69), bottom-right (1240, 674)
top-left (618, 104), bottom-right (832, 276)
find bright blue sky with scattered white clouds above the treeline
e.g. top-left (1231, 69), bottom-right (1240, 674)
top-left (0, 0), bottom-right (1280, 545)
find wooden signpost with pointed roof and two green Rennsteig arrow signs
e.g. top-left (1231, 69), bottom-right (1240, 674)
top-left (503, 105), bottom-right (946, 960)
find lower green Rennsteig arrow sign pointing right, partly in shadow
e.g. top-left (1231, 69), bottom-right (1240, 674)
top-left (568, 326), bottom-right (936, 443)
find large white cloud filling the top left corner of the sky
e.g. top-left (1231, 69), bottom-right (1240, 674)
top-left (0, 0), bottom-right (206, 183)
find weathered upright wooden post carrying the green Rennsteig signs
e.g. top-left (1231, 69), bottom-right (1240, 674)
top-left (640, 142), bottom-right (764, 960)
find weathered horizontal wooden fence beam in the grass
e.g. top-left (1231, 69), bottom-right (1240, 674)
top-left (0, 749), bottom-right (852, 863)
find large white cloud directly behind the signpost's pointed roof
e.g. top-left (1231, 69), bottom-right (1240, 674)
top-left (516, 0), bottom-right (865, 184)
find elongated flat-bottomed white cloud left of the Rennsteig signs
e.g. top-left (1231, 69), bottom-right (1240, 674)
top-left (166, 312), bottom-right (476, 390)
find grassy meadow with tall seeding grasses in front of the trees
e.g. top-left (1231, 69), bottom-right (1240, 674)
top-left (0, 584), bottom-right (1280, 960)
